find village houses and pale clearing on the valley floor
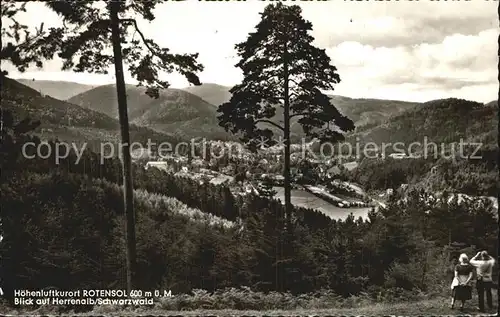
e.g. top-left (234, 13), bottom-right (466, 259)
top-left (140, 140), bottom-right (498, 219)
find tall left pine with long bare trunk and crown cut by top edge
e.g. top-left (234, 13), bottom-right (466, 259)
top-left (18, 0), bottom-right (203, 290)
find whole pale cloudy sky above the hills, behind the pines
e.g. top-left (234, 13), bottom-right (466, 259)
top-left (2, 0), bottom-right (499, 102)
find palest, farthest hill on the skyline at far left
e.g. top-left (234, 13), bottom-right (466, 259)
top-left (16, 79), bottom-right (97, 100)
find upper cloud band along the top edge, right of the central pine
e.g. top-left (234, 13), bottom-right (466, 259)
top-left (304, 0), bottom-right (498, 47)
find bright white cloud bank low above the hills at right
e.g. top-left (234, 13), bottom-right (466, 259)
top-left (327, 29), bottom-right (499, 100)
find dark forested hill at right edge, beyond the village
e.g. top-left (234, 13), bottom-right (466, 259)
top-left (347, 98), bottom-right (500, 196)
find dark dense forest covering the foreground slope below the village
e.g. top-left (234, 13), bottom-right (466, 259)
top-left (1, 108), bottom-right (498, 308)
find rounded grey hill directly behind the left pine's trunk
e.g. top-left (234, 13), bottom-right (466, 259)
top-left (68, 85), bottom-right (232, 139)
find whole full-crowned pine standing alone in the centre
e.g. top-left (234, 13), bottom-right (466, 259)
top-left (218, 3), bottom-right (354, 230)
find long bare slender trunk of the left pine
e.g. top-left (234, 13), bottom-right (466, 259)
top-left (110, 1), bottom-right (136, 294)
